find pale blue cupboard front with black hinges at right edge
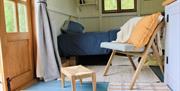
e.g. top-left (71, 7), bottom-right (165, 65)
top-left (165, 1), bottom-right (180, 91)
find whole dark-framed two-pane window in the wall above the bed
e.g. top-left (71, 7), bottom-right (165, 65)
top-left (102, 0), bottom-right (137, 13)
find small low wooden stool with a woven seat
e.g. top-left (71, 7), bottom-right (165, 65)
top-left (61, 65), bottom-right (96, 91)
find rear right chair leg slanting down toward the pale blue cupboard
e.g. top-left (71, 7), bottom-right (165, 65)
top-left (152, 43), bottom-right (164, 73)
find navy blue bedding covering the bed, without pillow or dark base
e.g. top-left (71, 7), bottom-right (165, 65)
top-left (58, 29), bottom-right (119, 57)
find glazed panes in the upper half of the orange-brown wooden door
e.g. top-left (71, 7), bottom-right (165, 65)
top-left (4, 0), bottom-right (28, 33)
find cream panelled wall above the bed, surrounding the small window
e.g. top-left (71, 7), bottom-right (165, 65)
top-left (47, 0), bottom-right (163, 32)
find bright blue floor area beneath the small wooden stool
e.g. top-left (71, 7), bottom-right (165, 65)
top-left (23, 80), bottom-right (108, 91)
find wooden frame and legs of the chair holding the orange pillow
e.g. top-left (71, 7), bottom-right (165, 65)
top-left (104, 21), bottom-right (164, 90)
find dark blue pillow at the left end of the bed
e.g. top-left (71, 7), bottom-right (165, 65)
top-left (61, 20), bottom-right (84, 33)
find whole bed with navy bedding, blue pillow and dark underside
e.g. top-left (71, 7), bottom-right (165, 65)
top-left (57, 21), bottom-right (120, 65)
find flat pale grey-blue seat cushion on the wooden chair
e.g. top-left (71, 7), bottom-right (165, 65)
top-left (100, 42), bottom-right (144, 52)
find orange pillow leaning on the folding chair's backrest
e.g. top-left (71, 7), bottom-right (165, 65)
top-left (128, 13), bottom-right (162, 48)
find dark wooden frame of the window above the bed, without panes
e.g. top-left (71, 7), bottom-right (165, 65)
top-left (102, 0), bottom-right (137, 14)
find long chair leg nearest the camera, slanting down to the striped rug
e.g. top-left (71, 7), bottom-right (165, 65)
top-left (130, 53), bottom-right (147, 90)
